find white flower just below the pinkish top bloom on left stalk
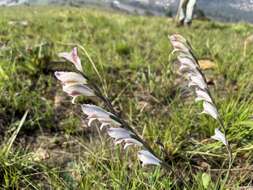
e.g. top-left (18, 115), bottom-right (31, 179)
top-left (54, 71), bottom-right (87, 85)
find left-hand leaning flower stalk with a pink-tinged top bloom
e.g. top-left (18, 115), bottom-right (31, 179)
top-left (55, 48), bottom-right (174, 171)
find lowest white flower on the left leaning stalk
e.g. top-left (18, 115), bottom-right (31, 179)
top-left (138, 150), bottom-right (161, 166)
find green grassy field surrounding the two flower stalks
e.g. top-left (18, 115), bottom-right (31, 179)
top-left (0, 7), bottom-right (253, 190)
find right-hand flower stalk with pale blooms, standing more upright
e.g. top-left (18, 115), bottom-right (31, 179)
top-left (169, 34), bottom-right (232, 168)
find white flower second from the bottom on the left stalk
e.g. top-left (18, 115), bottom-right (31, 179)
top-left (107, 127), bottom-right (142, 148)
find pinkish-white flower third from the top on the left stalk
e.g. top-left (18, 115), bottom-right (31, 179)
top-left (63, 84), bottom-right (96, 104)
